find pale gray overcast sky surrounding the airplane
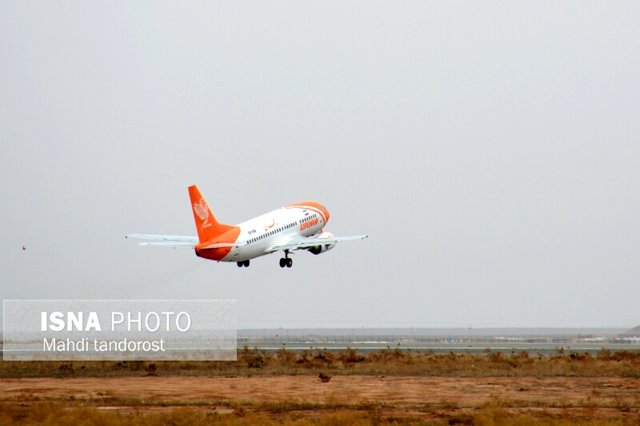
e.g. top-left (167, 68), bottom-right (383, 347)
top-left (0, 0), bottom-right (640, 327)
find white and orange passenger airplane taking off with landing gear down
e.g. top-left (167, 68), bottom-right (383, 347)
top-left (125, 185), bottom-right (368, 268)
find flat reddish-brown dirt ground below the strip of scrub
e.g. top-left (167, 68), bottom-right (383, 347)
top-left (0, 375), bottom-right (640, 424)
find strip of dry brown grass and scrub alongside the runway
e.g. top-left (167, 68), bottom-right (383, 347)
top-left (0, 347), bottom-right (640, 378)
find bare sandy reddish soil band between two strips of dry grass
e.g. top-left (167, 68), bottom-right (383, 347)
top-left (0, 376), bottom-right (640, 416)
